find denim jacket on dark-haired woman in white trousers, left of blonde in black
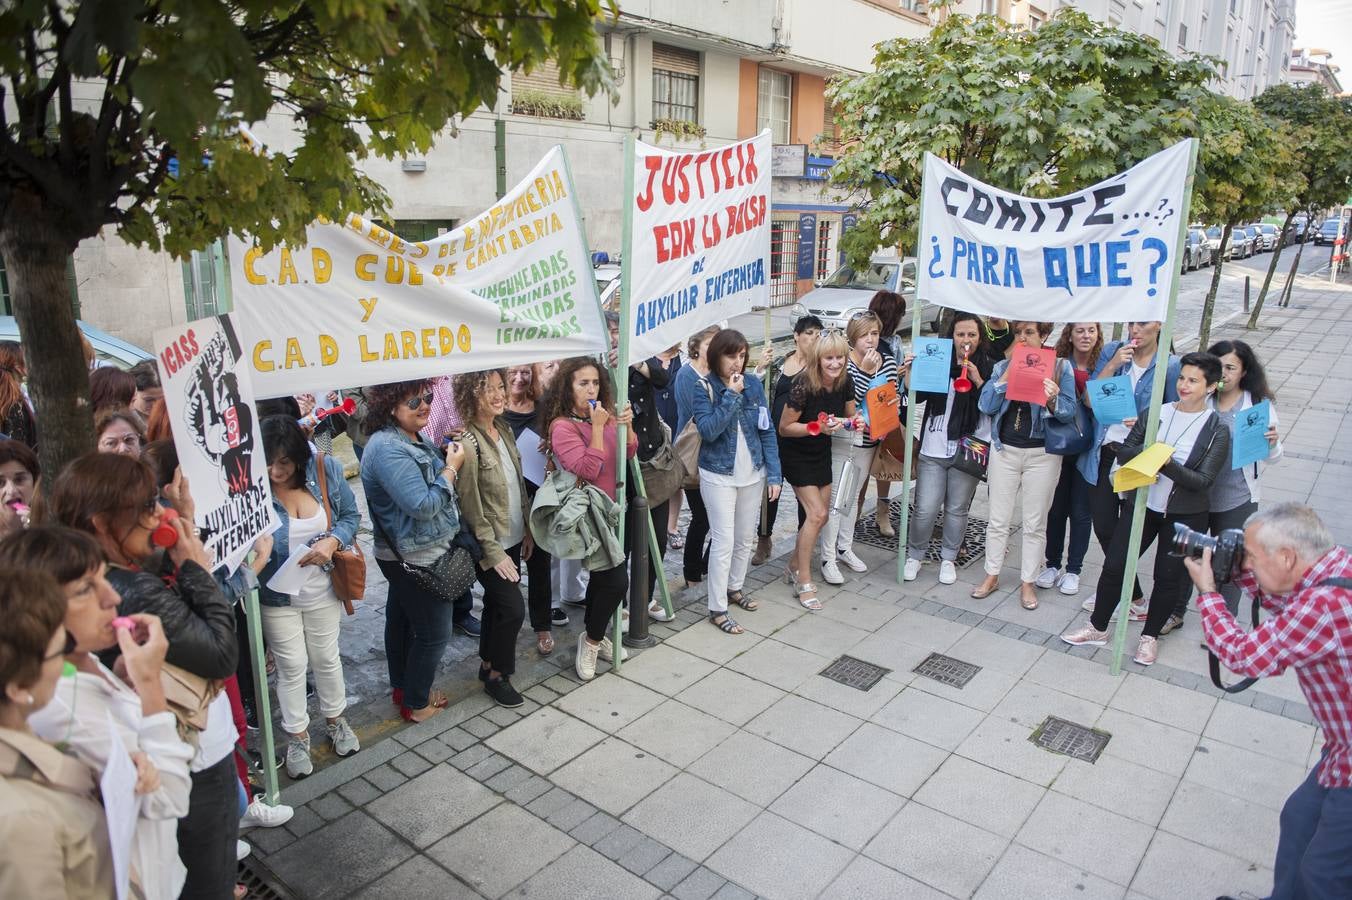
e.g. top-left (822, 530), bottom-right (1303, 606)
top-left (681, 374), bottom-right (783, 484)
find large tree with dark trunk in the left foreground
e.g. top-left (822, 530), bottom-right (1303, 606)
top-left (0, 0), bottom-right (615, 474)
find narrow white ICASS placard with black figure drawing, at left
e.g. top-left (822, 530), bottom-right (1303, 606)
top-left (155, 316), bottom-right (277, 572)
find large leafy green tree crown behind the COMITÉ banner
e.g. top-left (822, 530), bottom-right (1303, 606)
top-left (831, 8), bottom-right (1214, 262)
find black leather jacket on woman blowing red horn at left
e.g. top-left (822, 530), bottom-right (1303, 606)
top-left (108, 561), bottom-right (239, 680)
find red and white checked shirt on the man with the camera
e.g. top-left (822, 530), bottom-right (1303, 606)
top-left (1197, 547), bottom-right (1352, 788)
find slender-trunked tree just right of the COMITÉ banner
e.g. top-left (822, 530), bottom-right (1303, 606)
top-left (1192, 95), bottom-right (1305, 347)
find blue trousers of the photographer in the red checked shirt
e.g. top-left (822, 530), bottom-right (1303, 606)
top-left (1271, 757), bottom-right (1352, 900)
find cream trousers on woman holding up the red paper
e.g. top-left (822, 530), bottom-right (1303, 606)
top-left (986, 446), bottom-right (1061, 581)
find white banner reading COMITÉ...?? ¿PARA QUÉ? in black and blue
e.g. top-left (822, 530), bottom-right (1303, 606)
top-left (917, 141), bottom-right (1190, 322)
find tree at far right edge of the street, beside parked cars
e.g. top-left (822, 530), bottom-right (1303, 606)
top-left (1247, 84), bottom-right (1352, 328)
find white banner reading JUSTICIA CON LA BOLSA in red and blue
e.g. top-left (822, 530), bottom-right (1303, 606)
top-left (622, 131), bottom-right (771, 362)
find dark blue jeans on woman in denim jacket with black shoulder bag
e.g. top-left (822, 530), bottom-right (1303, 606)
top-left (376, 559), bottom-right (456, 709)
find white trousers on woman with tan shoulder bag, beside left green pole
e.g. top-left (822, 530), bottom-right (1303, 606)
top-left (260, 600), bottom-right (347, 734)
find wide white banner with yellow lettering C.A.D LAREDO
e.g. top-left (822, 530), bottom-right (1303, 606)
top-left (230, 147), bottom-right (606, 397)
